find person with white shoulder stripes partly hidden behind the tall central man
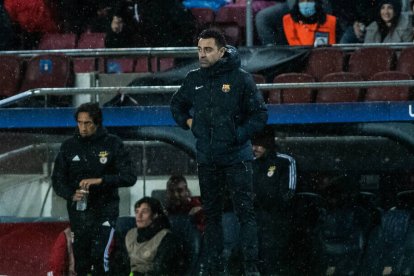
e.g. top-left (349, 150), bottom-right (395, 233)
top-left (252, 128), bottom-right (296, 275)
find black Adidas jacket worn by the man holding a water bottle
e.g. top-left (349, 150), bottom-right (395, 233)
top-left (52, 127), bottom-right (137, 221)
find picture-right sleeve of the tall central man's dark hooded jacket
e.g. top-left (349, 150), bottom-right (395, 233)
top-left (236, 73), bottom-right (267, 144)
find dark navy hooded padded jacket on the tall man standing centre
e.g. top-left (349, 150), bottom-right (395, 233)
top-left (171, 46), bottom-right (267, 165)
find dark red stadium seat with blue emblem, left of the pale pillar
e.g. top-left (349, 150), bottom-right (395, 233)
top-left (20, 55), bottom-right (74, 106)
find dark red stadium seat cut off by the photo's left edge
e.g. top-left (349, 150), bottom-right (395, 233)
top-left (0, 56), bottom-right (23, 98)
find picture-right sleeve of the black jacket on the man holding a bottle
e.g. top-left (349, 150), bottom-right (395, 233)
top-left (100, 138), bottom-right (137, 189)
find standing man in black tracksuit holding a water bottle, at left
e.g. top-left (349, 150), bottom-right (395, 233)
top-left (52, 103), bottom-right (137, 275)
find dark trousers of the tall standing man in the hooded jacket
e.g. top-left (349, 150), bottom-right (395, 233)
top-left (198, 162), bottom-right (258, 272)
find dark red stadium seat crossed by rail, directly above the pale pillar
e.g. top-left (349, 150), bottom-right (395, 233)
top-left (73, 33), bottom-right (105, 73)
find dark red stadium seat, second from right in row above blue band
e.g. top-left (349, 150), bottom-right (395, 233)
top-left (315, 72), bottom-right (363, 103)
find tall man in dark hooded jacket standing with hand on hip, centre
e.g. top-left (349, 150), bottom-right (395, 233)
top-left (171, 30), bottom-right (267, 275)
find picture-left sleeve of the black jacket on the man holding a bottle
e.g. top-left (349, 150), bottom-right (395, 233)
top-left (52, 146), bottom-right (74, 200)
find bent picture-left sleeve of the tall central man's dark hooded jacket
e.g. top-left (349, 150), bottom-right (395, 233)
top-left (170, 75), bottom-right (193, 129)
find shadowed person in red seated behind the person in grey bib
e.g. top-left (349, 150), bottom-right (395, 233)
top-left (166, 175), bottom-right (204, 232)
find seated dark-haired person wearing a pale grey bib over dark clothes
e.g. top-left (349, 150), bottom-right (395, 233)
top-left (125, 197), bottom-right (187, 276)
